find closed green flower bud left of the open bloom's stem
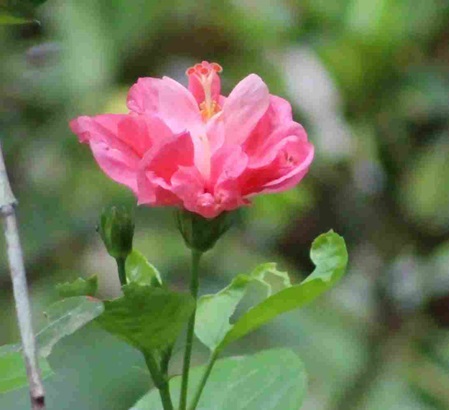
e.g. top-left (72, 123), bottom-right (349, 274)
top-left (98, 206), bottom-right (134, 260)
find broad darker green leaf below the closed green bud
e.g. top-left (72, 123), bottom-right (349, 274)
top-left (97, 282), bottom-right (195, 352)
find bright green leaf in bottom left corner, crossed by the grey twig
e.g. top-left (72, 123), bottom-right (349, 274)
top-left (0, 345), bottom-right (53, 393)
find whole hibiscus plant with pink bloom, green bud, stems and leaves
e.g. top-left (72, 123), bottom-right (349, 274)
top-left (0, 61), bottom-right (348, 410)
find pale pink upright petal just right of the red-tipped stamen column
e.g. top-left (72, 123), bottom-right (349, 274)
top-left (222, 74), bottom-right (270, 144)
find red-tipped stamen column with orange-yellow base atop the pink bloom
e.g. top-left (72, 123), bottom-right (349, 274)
top-left (186, 61), bottom-right (223, 121)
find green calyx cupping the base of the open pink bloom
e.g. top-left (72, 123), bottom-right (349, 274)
top-left (176, 209), bottom-right (233, 252)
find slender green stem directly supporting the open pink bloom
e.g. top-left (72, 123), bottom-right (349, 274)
top-left (179, 250), bottom-right (202, 410)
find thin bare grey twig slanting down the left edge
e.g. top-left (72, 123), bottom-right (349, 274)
top-left (0, 145), bottom-right (45, 410)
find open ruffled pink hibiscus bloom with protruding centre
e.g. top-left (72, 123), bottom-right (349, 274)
top-left (70, 61), bottom-right (314, 218)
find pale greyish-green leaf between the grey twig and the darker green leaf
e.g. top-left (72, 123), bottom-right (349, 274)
top-left (36, 296), bottom-right (103, 357)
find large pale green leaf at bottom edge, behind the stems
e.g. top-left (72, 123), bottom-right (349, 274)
top-left (130, 349), bottom-right (307, 410)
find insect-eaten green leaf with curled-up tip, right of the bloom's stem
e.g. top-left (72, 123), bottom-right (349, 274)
top-left (195, 231), bottom-right (348, 351)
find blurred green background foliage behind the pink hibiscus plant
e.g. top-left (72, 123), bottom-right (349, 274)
top-left (0, 0), bottom-right (449, 410)
